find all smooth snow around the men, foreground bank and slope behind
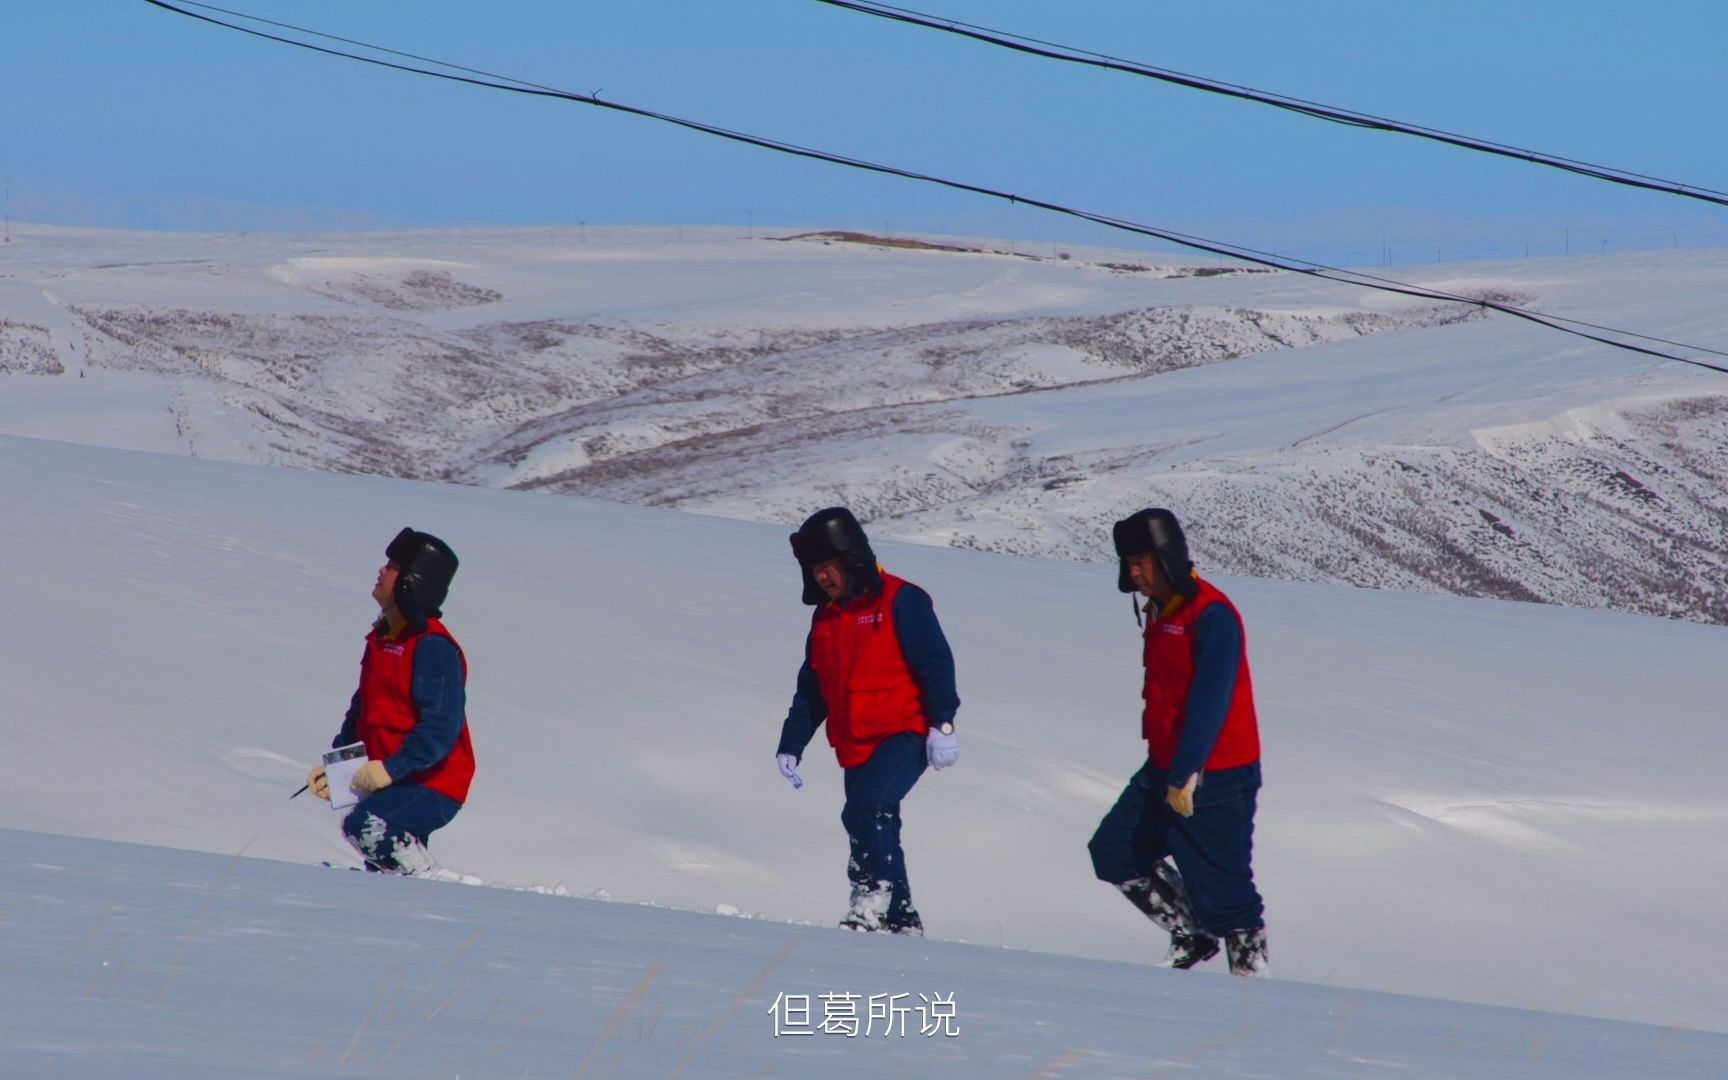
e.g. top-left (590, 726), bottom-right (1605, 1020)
top-left (0, 435), bottom-right (1728, 1077)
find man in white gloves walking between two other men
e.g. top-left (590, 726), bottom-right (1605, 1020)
top-left (776, 506), bottom-right (961, 937)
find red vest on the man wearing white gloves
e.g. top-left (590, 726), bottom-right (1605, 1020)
top-left (810, 574), bottom-right (930, 769)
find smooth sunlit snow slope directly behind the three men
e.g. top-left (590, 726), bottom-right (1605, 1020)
top-left (0, 437), bottom-right (1728, 1043)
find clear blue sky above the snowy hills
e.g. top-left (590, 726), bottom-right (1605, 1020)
top-left (0, 0), bottom-right (1728, 264)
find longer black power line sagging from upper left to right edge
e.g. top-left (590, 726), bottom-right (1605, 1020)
top-left (143, 0), bottom-right (1728, 375)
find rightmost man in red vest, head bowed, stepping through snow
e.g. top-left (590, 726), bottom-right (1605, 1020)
top-left (1090, 510), bottom-right (1267, 975)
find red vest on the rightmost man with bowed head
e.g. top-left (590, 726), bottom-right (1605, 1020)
top-left (1140, 575), bottom-right (1260, 771)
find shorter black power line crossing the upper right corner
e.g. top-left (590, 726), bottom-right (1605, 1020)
top-left (816, 0), bottom-right (1728, 206)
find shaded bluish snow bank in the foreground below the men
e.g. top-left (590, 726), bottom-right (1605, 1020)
top-left (0, 829), bottom-right (1728, 1080)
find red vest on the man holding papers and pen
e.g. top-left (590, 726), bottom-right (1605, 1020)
top-left (359, 619), bottom-right (473, 802)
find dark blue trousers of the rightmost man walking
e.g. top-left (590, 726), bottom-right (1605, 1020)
top-left (1089, 762), bottom-right (1265, 937)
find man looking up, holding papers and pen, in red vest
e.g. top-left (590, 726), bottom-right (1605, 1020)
top-left (306, 529), bottom-right (473, 874)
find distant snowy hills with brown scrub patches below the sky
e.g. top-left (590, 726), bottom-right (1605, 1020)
top-left (0, 226), bottom-right (1728, 622)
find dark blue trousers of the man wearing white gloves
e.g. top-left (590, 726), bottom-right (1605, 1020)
top-left (840, 733), bottom-right (930, 928)
